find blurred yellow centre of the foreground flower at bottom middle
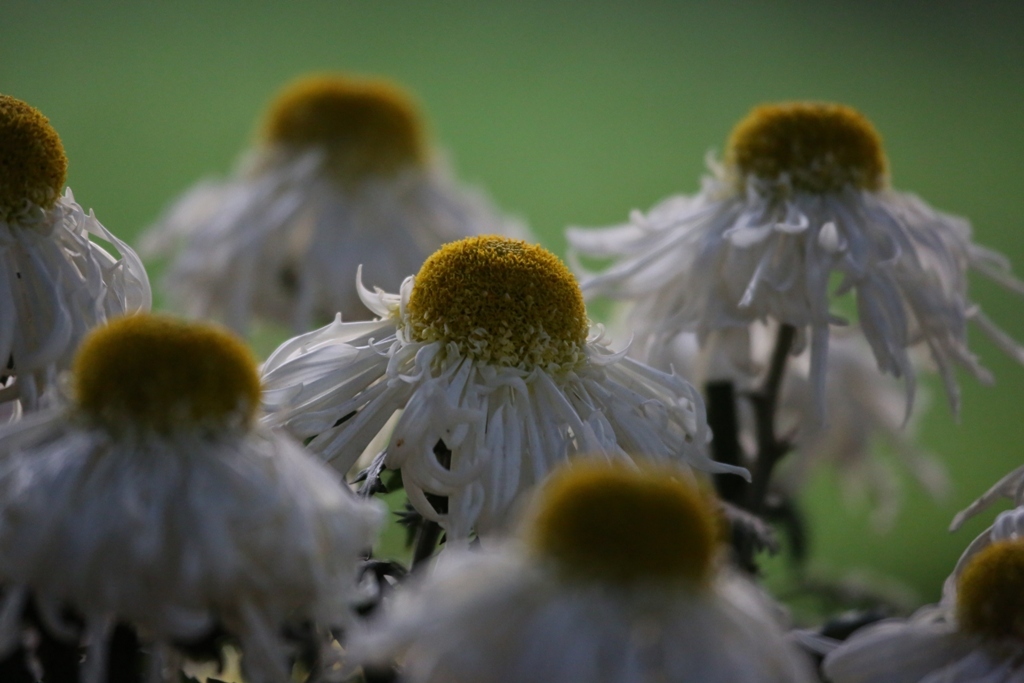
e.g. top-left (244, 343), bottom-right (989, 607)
top-left (528, 461), bottom-right (721, 585)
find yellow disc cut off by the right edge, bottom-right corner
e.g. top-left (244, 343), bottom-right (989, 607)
top-left (956, 539), bottom-right (1024, 646)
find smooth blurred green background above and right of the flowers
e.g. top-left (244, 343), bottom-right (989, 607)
top-left (0, 0), bottom-right (1024, 601)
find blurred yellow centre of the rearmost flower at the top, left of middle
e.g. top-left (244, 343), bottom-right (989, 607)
top-left (264, 76), bottom-right (427, 182)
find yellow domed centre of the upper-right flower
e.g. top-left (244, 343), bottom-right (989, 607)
top-left (726, 102), bottom-right (886, 194)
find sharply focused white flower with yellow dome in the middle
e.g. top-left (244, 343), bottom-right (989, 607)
top-left (263, 237), bottom-right (746, 540)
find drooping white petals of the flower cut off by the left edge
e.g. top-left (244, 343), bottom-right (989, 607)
top-left (0, 189), bottom-right (152, 411)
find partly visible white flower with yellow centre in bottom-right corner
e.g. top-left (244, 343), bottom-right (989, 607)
top-left (823, 535), bottom-right (1024, 683)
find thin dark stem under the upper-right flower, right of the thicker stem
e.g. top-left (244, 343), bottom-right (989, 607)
top-left (745, 325), bottom-right (797, 515)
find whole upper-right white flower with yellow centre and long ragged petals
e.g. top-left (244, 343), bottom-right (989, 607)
top-left (567, 99), bottom-right (1024, 411)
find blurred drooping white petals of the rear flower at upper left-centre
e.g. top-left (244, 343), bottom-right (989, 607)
top-left (141, 147), bottom-right (524, 332)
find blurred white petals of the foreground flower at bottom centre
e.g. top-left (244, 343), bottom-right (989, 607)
top-left (353, 543), bottom-right (813, 683)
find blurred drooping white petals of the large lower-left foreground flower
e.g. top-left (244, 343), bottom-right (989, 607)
top-left (0, 410), bottom-right (383, 683)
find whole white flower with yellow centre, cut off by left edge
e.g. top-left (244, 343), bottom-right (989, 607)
top-left (0, 95), bottom-right (151, 413)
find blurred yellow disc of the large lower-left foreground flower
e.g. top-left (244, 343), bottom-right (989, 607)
top-left (74, 314), bottom-right (260, 433)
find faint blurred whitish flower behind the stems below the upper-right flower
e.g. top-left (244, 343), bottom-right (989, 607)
top-left (651, 324), bottom-right (949, 528)
